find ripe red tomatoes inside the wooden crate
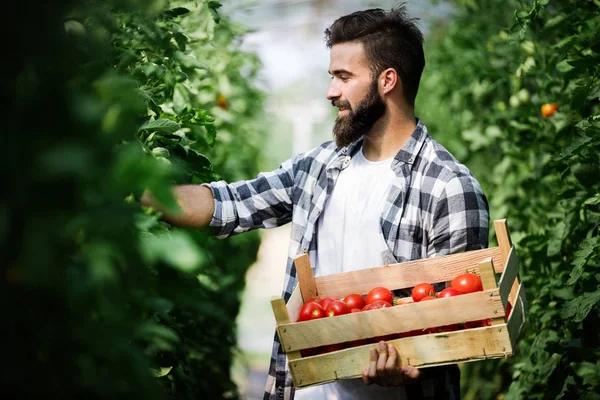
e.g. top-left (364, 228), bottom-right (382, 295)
top-left (298, 272), bottom-right (511, 356)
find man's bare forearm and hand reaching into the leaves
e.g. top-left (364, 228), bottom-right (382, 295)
top-left (141, 185), bottom-right (215, 228)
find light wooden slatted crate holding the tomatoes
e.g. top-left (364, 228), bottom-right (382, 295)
top-left (271, 220), bottom-right (527, 388)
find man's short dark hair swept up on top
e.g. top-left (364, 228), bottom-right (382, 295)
top-left (325, 5), bottom-right (425, 107)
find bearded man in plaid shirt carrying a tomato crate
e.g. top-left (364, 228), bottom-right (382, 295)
top-left (143, 4), bottom-right (489, 400)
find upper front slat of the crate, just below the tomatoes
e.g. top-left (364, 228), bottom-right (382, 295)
top-left (278, 289), bottom-right (504, 352)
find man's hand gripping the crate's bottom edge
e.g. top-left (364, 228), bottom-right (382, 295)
top-left (363, 340), bottom-right (421, 387)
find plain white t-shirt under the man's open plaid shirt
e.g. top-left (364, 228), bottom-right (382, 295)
top-left (296, 149), bottom-right (406, 400)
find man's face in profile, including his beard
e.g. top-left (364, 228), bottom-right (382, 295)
top-left (327, 42), bottom-right (386, 147)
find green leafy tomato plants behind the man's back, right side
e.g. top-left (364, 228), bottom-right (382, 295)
top-left (417, 0), bottom-right (600, 399)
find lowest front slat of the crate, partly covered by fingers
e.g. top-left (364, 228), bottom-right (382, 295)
top-left (289, 325), bottom-right (512, 387)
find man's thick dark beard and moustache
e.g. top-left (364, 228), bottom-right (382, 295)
top-left (331, 81), bottom-right (386, 147)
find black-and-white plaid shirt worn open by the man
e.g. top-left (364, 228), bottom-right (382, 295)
top-left (207, 120), bottom-right (489, 400)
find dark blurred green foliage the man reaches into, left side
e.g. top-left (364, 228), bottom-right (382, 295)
top-left (0, 0), bottom-right (264, 399)
